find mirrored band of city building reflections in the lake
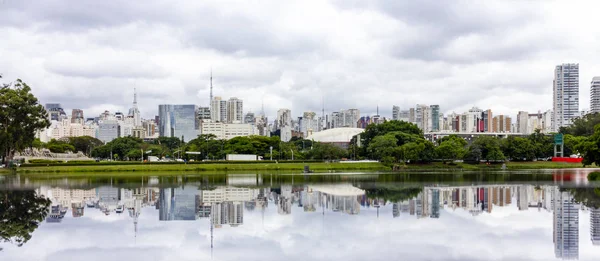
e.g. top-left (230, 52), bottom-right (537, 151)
top-left (30, 180), bottom-right (600, 259)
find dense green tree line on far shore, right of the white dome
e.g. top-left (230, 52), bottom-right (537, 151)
top-left (351, 121), bottom-right (583, 164)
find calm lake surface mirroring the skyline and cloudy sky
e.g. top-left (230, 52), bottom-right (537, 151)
top-left (0, 170), bottom-right (600, 261)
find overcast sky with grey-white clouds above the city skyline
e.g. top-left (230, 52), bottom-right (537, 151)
top-left (0, 0), bottom-right (600, 118)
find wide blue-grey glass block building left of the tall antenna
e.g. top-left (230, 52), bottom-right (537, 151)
top-left (158, 104), bottom-right (200, 142)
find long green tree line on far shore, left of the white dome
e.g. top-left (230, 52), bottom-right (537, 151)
top-left (86, 134), bottom-right (348, 160)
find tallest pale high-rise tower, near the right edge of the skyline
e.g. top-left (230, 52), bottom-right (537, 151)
top-left (552, 63), bottom-right (579, 131)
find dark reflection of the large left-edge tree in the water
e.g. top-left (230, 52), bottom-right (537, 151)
top-left (0, 190), bottom-right (51, 246)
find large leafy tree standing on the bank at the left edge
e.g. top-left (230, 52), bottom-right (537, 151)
top-left (0, 79), bottom-right (50, 162)
